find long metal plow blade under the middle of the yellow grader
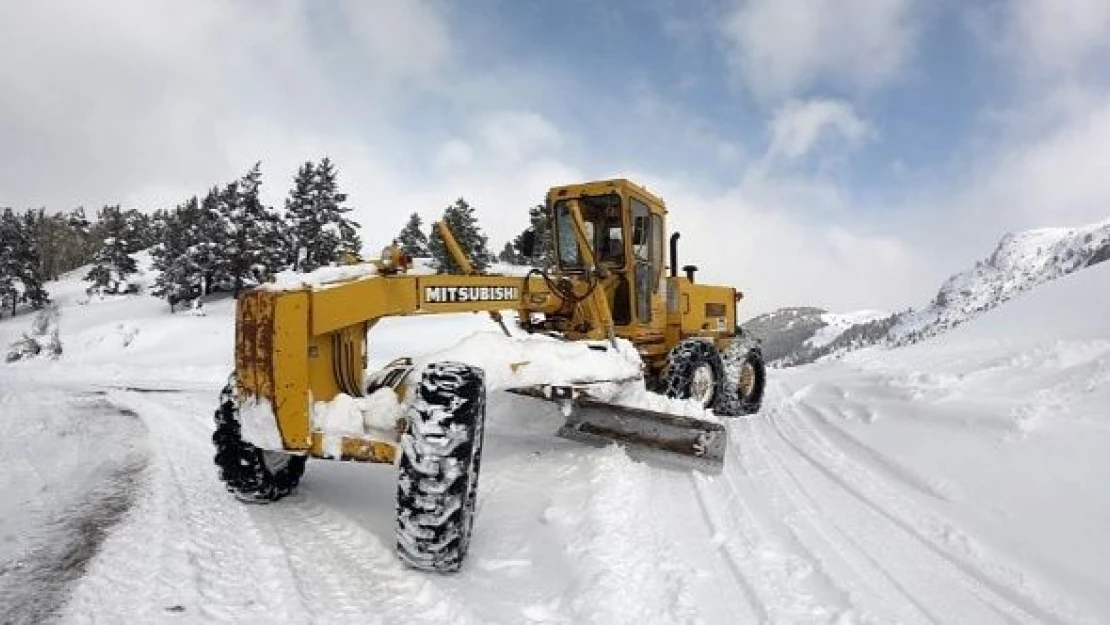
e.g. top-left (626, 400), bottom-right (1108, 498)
top-left (508, 385), bottom-right (728, 474)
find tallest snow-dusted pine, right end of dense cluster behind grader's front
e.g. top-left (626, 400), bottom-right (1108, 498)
top-left (285, 157), bottom-right (362, 272)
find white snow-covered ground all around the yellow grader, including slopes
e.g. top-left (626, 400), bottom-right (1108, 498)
top-left (0, 263), bottom-right (1110, 624)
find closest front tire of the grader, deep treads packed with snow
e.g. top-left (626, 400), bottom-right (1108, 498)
top-left (396, 362), bottom-right (485, 573)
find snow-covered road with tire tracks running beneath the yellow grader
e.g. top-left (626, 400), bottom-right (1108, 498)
top-left (6, 355), bottom-right (1107, 623)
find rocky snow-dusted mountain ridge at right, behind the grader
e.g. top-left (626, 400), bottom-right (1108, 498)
top-left (744, 220), bottom-right (1110, 366)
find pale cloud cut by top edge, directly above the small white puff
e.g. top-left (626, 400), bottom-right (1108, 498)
top-left (722, 0), bottom-right (918, 100)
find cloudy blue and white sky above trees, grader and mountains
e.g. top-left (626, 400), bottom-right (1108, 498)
top-left (0, 0), bottom-right (1110, 313)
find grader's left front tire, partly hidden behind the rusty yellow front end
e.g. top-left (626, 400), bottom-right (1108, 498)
top-left (212, 383), bottom-right (305, 503)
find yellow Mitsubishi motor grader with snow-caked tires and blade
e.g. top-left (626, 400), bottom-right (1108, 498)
top-left (213, 180), bottom-right (765, 572)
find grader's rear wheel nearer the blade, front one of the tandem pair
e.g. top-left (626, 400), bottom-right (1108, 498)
top-left (659, 339), bottom-right (725, 410)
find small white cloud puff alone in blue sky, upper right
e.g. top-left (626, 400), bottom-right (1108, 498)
top-left (767, 99), bottom-right (874, 160)
